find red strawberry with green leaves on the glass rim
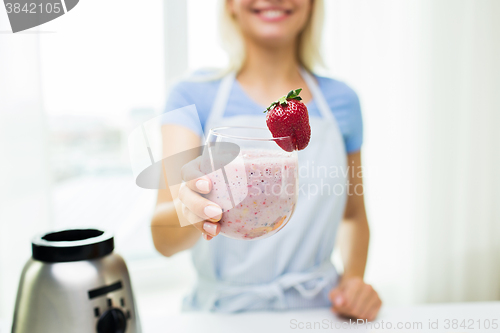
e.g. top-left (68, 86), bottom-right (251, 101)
top-left (264, 88), bottom-right (311, 151)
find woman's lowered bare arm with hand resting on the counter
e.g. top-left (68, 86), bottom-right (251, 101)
top-left (330, 152), bottom-right (382, 320)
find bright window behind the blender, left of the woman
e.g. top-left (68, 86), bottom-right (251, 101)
top-left (40, 0), bottom-right (166, 257)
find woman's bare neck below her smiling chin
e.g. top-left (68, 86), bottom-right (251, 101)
top-left (238, 41), bottom-right (300, 85)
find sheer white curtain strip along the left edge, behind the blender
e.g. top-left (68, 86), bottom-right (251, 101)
top-left (0, 21), bottom-right (51, 319)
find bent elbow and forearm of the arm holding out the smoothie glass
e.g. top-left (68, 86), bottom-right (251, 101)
top-left (151, 201), bottom-right (200, 257)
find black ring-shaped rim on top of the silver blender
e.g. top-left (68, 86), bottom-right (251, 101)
top-left (31, 229), bottom-right (115, 263)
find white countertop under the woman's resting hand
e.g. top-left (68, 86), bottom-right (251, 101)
top-left (141, 302), bottom-right (500, 333)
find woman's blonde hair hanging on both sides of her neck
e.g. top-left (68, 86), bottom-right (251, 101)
top-left (219, 0), bottom-right (324, 72)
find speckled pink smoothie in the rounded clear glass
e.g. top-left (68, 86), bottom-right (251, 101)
top-left (205, 150), bottom-right (298, 240)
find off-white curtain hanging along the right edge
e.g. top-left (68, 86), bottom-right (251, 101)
top-left (416, 0), bottom-right (500, 302)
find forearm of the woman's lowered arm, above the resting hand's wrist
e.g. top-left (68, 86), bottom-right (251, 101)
top-left (338, 212), bottom-right (370, 278)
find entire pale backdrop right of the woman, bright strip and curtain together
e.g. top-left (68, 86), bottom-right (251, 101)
top-left (324, 0), bottom-right (500, 304)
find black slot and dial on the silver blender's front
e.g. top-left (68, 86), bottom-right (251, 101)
top-left (88, 281), bottom-right (131, 333)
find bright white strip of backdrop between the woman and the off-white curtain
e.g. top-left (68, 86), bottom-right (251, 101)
top-left (324, 0), bottom-right (428, 304)
